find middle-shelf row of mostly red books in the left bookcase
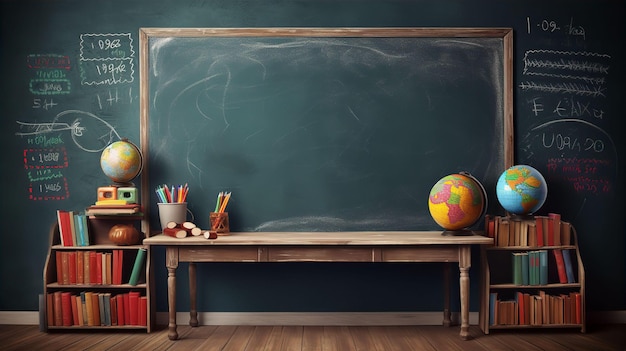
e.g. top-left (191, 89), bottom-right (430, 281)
top-left (55, 248), bottom-right (146, 285)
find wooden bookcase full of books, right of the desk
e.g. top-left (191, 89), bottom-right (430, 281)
top-left (479, 213), bottom-right (585, 334)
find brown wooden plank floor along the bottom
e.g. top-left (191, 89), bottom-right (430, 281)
top-left (0, 324), bottom-right (626, 351)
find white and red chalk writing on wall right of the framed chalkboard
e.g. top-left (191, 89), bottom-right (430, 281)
top-left (518, 42), bottom-right (618, 195)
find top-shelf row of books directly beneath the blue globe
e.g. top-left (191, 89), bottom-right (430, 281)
top-left (485, 213), bottom-right (572, 247)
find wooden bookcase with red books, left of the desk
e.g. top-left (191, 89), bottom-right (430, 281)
top-left (42, 213), bottom-right (155, 333)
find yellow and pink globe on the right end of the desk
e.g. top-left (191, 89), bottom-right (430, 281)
top-left (428, 173), bottom-right (487, 230)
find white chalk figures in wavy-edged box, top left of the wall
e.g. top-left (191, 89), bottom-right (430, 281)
top-left (80, 33), bottom-right (135, 85)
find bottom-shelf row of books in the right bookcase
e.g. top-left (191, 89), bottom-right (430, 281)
top-left (489, 291), bottom-right (583, 326)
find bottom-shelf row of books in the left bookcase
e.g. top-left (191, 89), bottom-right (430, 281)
top-left (46, 291), bottom-right (148, 327)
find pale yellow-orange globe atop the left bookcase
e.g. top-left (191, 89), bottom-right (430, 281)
top-left (100, 139), bottom-right (143, 183)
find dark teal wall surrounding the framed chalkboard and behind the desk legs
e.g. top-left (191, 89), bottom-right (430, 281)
top-left (0, 0), bottom-right (626, 311)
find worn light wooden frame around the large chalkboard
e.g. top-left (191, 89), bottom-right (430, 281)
top-left (139, 27), bottom-right (514, 235)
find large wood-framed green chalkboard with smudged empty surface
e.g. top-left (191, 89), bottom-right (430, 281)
top-left (140, 28), bottom-right (513, 231)
